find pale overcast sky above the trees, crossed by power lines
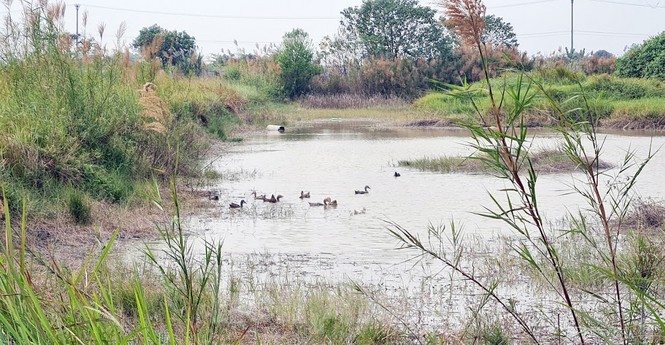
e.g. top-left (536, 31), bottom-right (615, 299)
top-left (5, 0), bottom-right (665, 56)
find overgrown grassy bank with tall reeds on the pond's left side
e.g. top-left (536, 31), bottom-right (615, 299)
top-left (0, 6), bottom-right (258, 224)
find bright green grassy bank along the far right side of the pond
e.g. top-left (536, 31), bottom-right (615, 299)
top-left (414, 68), bottom-right (665, 129)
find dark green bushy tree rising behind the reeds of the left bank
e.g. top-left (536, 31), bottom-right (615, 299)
top-left (132, 24), bottom-right (201, 72)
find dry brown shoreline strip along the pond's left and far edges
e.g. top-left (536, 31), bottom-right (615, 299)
top-left (12, 109), bottom-right (665, 262)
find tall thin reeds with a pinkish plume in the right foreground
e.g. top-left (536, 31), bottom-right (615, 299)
top-left (391, 0), bottom-right (665, 344)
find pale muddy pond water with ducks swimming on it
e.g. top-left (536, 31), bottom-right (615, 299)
top-left (184, 121), bottom-right (665, 328)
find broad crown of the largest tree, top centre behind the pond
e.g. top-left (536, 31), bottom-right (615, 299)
top-left (341, 0), bottom-right (452, 60)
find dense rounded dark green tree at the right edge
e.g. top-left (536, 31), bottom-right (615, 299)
top-left (616, 32), bottom-right (665, 80)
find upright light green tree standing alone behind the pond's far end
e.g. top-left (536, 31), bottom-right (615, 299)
top-left (275, 29), bottom-right (320, 98)
